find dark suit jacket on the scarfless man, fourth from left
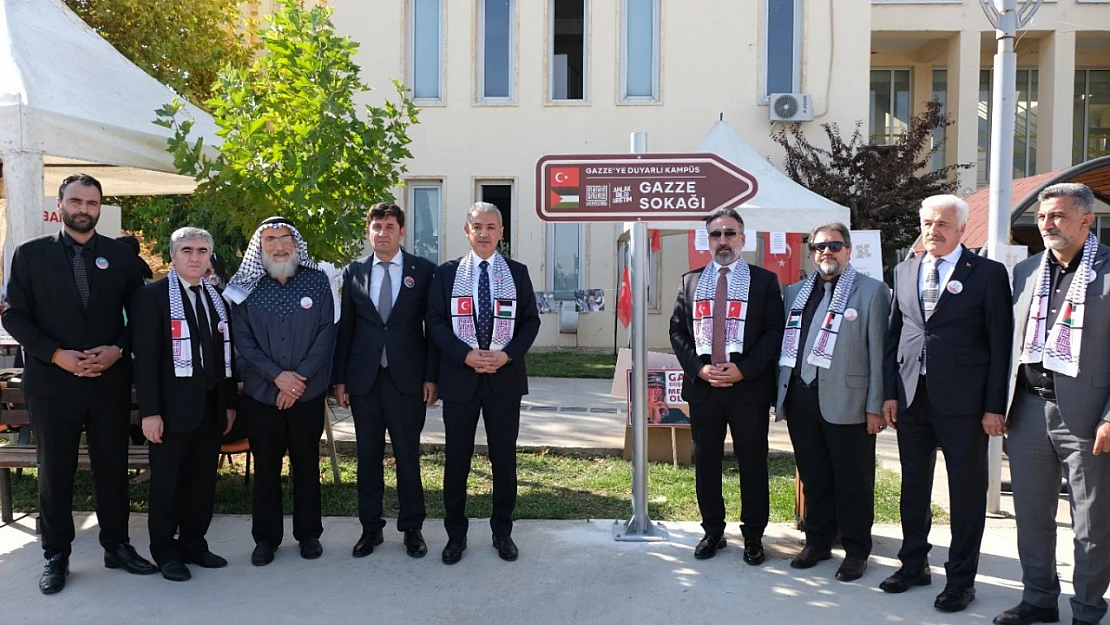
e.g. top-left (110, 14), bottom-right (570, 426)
top-left (332, 251), bottom-right (440, 395)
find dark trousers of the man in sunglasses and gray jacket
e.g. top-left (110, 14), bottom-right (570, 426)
top-left (786, 381), bottom-right (875, 560)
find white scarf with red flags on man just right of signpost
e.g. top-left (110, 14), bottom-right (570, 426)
top-left (694, 259), bottom-right (751, 356)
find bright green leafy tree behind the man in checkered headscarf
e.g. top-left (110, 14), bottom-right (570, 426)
top-left (155, 0), bottom-right (417, 263)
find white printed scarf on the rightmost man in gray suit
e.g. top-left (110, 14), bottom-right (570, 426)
top-left (1020, 233), bottom-right (1099, 377)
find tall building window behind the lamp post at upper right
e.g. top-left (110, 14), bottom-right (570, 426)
top-left (976, 69), bottom-right (1038, 187)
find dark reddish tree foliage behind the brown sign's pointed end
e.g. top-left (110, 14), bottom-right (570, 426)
top-left (773, 100), bottom-right (971, 259)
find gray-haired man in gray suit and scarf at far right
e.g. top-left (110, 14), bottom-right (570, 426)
top-left (995, 183), bottom-right (1110, 625)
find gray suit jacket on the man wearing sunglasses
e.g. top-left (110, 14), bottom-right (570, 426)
top-left (775, 273), bottom-right (890, 425)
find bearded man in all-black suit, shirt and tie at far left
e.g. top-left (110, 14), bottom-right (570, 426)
top-left (3, 174), bottom-right (155, 594)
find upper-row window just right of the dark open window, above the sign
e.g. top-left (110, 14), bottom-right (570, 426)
top-left (620, 0), bottom-right (659, 102)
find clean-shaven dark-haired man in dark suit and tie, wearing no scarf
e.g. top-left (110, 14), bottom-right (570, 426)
top-left (332, 202), bottom-right (440, 557)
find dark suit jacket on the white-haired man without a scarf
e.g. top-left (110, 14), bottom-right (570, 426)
top-left (882, 250), bottom-right (1013, 416)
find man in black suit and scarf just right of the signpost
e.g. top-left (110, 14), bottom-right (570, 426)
top-left (670, 209), bottom-right (785, 565)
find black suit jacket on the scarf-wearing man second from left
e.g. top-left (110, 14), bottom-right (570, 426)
top-left (131, 279), bottom-right (238, 432)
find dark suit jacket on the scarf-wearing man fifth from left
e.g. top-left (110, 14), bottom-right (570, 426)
top-left (427, 259), bottom-right (539, 402)
